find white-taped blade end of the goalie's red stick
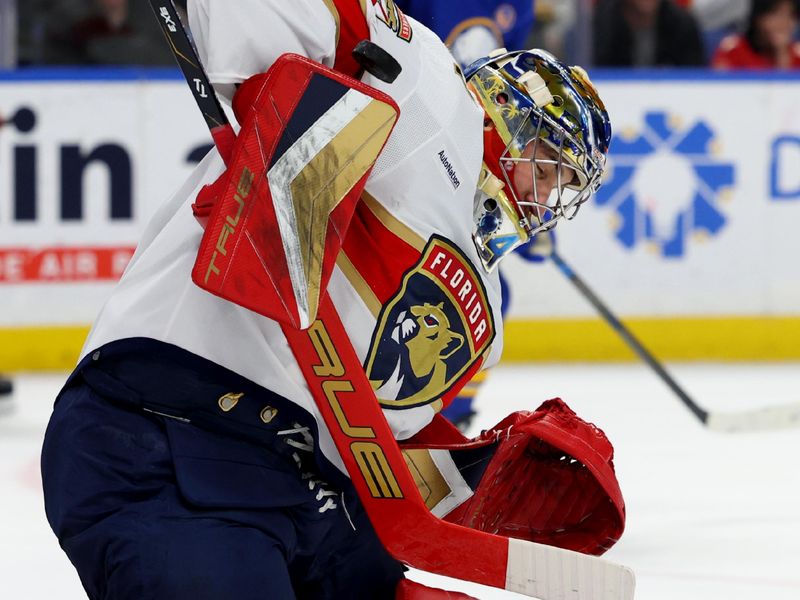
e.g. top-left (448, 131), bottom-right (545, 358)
top-left (506, 539), bottom-right (636, 600)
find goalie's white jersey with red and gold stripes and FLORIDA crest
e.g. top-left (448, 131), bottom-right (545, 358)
top-left (83, 0), bottom-right (502, 470)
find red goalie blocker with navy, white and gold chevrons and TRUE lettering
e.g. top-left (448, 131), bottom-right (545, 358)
top-left (192, 54), bottom-right (399, 329)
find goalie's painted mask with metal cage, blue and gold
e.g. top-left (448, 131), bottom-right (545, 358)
top-left (464, 49), bottom-right (611, 271)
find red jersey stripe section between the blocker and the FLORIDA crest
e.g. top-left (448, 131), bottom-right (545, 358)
top-left (342, 202), bottom-right (420, 304)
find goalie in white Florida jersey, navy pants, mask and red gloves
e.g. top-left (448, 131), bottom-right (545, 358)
top-left (42, 0), bottom-right (624, 600)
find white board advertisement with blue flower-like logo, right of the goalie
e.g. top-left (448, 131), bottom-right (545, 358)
top-left (504, 73), bottom-right (800, 318)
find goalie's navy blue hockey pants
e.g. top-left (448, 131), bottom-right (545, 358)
top-left (42, 376), bottom-right (403, 600)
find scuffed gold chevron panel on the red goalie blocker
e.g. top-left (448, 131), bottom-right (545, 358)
top-left (291, 100), bottom-right (397, 314)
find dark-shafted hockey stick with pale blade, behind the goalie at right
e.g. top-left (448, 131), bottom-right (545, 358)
top-left (550, 250), bottom-right (800, 431)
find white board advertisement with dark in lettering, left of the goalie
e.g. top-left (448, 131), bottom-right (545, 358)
top-left (0, 72), bottom-right (210, 326)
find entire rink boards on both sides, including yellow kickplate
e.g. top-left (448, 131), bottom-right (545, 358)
top-left (0, 65), bottom-right (800, 371)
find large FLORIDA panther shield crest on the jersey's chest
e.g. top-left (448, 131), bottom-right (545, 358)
top-left (366, 237), bottom-right (494, 409)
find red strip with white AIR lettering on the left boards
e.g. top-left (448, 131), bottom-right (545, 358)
top-left (0, 246), bottom-right (136, 284)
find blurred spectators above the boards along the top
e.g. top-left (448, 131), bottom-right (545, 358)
top-left (0, 0), bottom-right (800, 69)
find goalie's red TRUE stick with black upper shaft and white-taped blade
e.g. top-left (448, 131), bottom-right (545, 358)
top-left (150, 0), bottom-right (634, 600)
